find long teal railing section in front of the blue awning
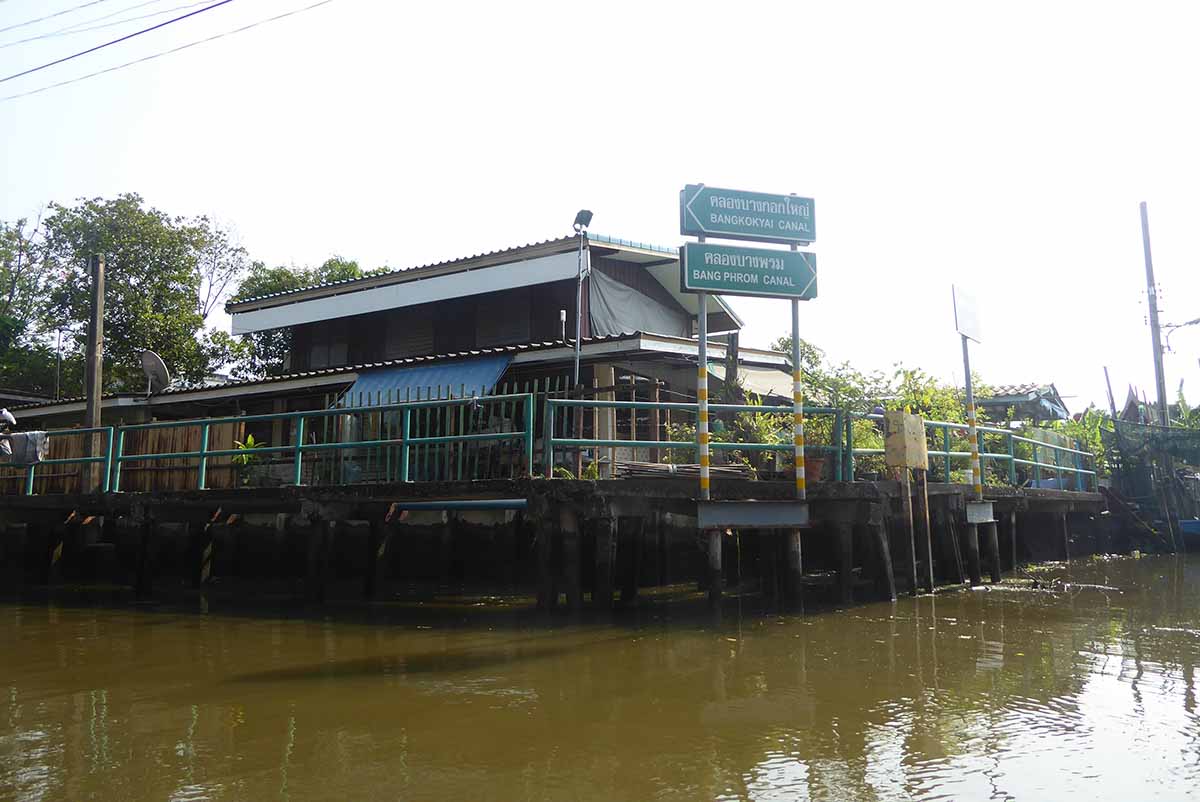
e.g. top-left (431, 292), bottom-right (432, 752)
top-left (110, 393), bottom-right (535, 492)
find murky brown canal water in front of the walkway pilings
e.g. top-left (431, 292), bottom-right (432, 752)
top-left (0, 557), bottom-right (1200, 801)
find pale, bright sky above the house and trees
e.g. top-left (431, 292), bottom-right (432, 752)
top-left (0, 0), bottom-right (1200, 411)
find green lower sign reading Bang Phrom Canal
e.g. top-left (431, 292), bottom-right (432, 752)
top-left (680, 243), bottom-right (817, 300)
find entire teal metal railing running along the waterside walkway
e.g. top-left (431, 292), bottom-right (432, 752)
top-left (7, 393), bottom-right (1097, 495)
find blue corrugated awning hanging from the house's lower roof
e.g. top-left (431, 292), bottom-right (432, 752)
top-left (342, 354), bottom-right (512, 407)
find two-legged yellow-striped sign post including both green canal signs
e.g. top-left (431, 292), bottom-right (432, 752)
top-left (679, 184), bottom-right (817, 603)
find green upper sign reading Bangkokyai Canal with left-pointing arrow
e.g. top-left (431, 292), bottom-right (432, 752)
top-left (679, 184), bottom-right (816, 244)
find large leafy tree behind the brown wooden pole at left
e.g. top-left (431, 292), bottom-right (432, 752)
top-left (41, 193), bottom-right (211, 390)
